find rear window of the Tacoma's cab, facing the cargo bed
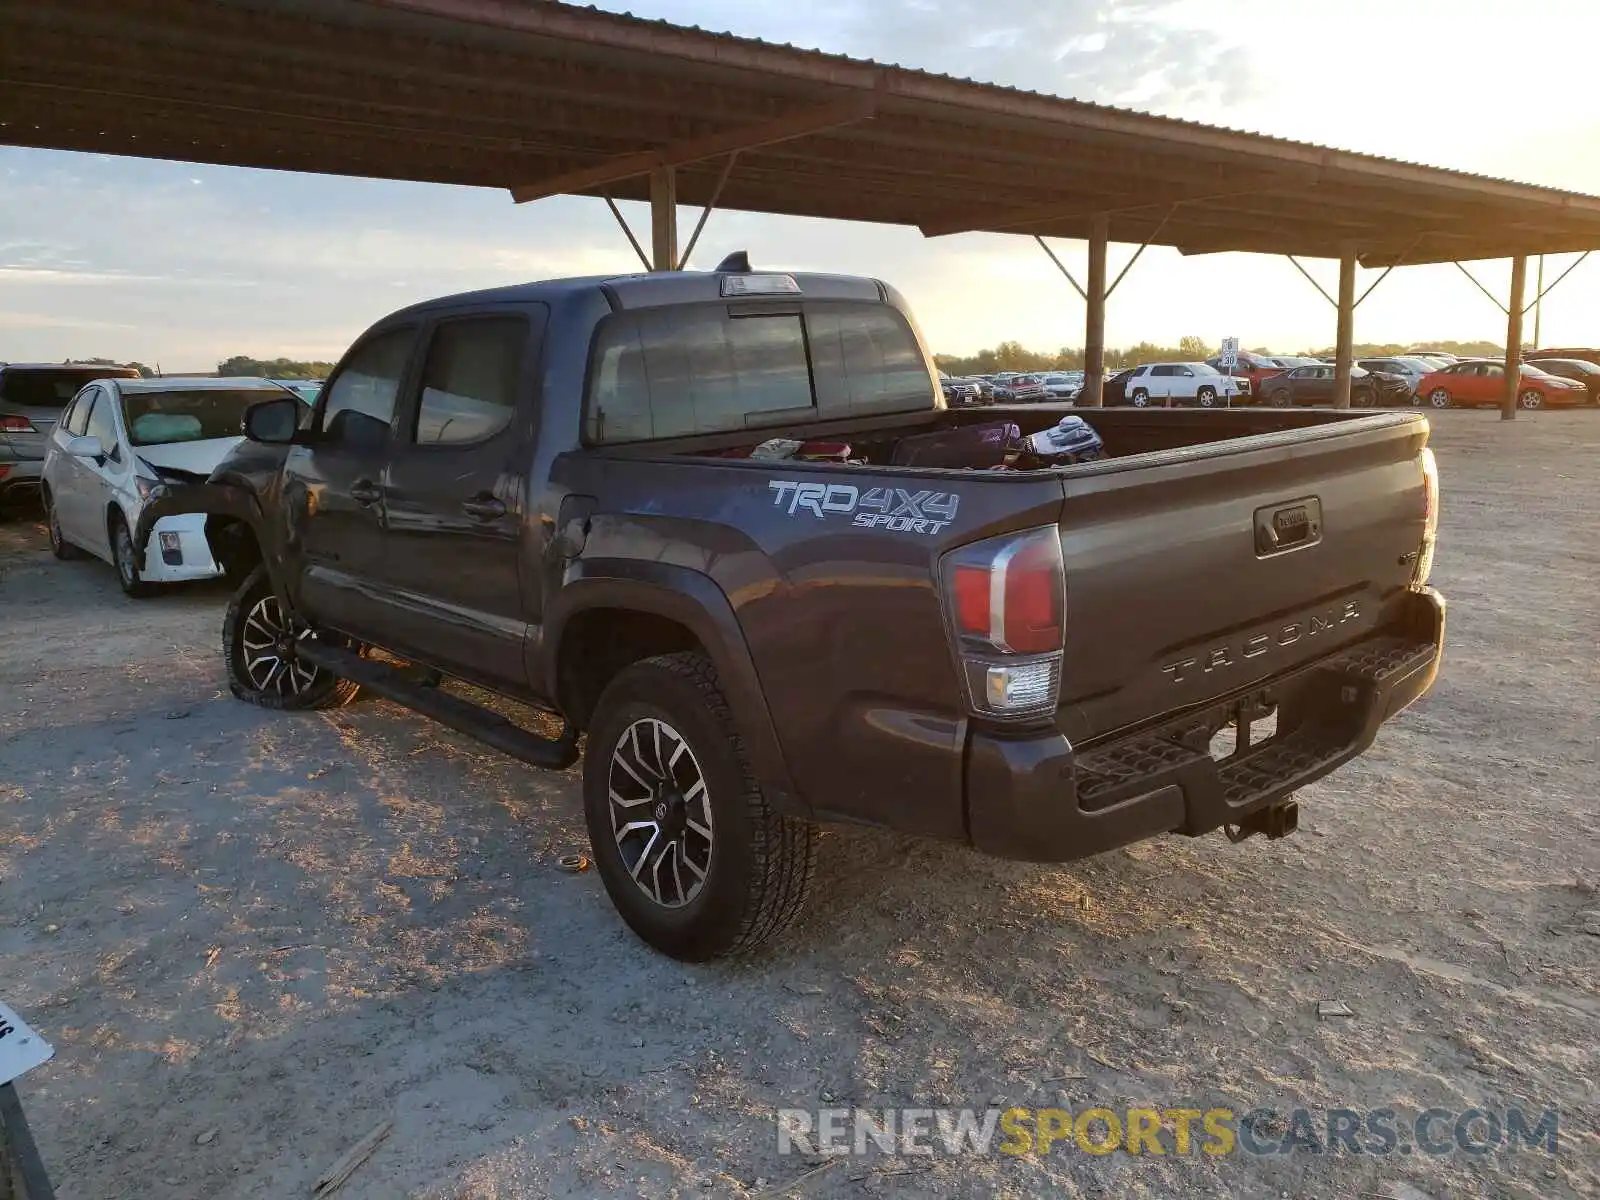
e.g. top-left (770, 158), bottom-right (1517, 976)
top-left (584, 301), bottom-right (939, 443)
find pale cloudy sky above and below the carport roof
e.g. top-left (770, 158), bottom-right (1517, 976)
top-left (0, 0), bottom-right (1600, 370)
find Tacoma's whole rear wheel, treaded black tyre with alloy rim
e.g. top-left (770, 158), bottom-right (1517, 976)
top-left (584, 653), bottom-right (816, 962)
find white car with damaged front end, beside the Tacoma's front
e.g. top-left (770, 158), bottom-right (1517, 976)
top-left (43, 378), bottom-right (290, 595)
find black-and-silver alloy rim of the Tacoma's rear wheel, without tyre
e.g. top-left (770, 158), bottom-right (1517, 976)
top-left (608, 717), bottom-right (715, 909)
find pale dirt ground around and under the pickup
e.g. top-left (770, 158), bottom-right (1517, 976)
top-left (0, 411), bottom-right (1600, 1200)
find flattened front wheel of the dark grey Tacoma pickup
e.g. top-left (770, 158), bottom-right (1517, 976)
top-left (222, 566), bottom-right (362, 712)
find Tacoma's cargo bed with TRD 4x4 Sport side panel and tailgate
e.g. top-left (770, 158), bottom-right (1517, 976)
top-left (563, 405), bottom-right (1427, 837)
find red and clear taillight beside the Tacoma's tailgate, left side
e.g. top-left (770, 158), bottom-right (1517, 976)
top-left (941, 525), bottom-right (1067, 717)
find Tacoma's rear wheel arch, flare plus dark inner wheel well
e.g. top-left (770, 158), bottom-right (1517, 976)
top-left (544, 560), bottom-right (811, 816)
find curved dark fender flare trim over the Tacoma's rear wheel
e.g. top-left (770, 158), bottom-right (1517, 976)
top-left (540, 558), bottom-right (811, 818)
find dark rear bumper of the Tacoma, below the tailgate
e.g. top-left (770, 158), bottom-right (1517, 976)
top-left (965, 589), bottom-right (1445, 862)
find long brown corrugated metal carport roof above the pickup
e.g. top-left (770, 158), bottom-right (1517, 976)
top-left (9, 0), bottom-right (1600, 266)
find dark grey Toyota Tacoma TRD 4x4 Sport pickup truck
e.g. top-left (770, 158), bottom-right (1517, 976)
top-left (134, 256), bottom-right (1445, 960)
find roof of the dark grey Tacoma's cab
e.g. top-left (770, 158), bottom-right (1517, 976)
top-left (384, 270), bottom-right (893, 317)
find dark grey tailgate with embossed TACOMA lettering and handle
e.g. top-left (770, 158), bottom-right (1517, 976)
top-left (1058, 414), bottom-right (1427, 744)
